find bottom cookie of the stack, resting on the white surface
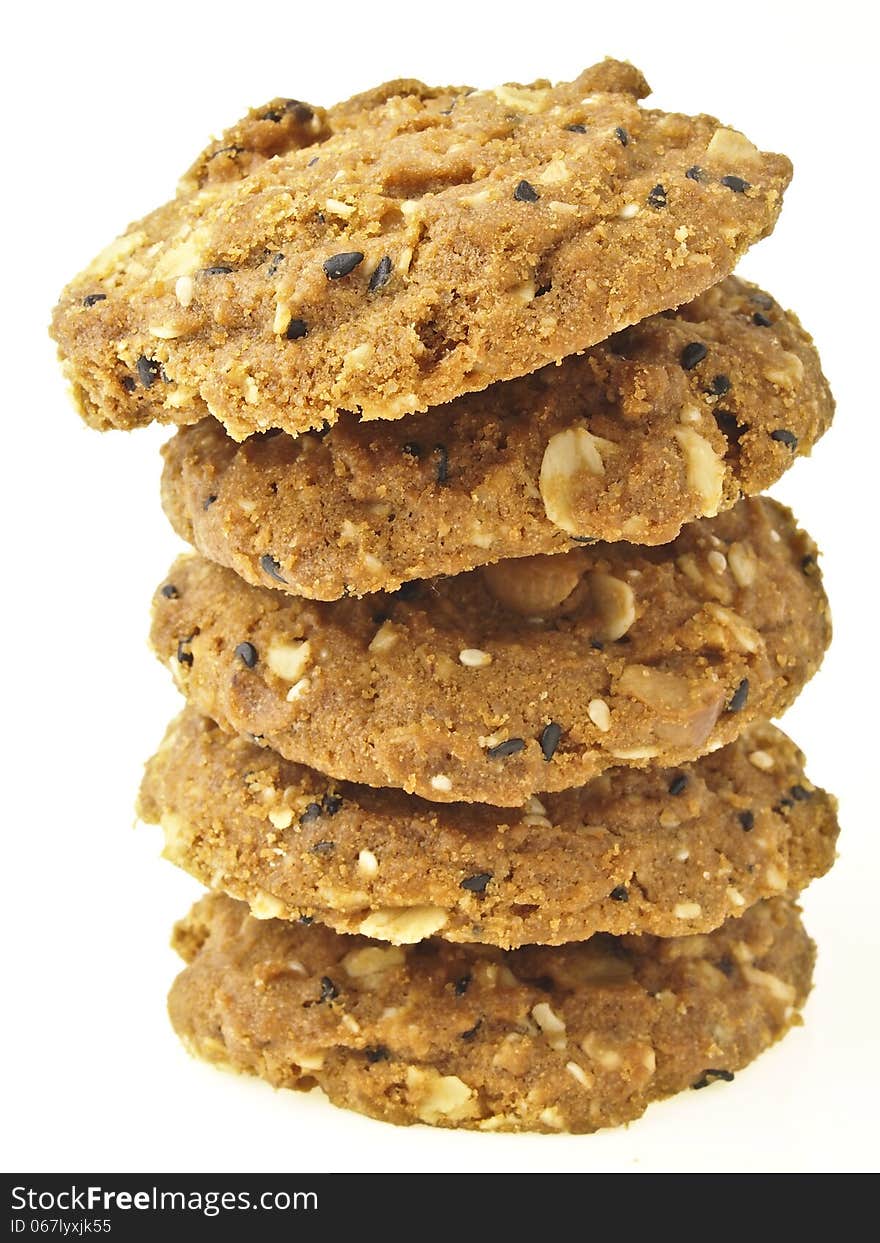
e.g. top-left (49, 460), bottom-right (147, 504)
top-left (169, 894), bottom-right (814, 1132)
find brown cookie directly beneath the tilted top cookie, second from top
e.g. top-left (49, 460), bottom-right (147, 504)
top-left (162, 277), bottom-right (834, 600)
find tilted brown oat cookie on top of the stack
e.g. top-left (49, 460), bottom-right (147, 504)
top-left (52, 61), bottom-right (791, 440)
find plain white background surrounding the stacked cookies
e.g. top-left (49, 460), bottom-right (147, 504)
top-left (0, 0), bottom-right (880, 1172)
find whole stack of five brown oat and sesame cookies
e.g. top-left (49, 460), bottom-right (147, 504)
top-left (53, 61), bottom-right (836, 1131)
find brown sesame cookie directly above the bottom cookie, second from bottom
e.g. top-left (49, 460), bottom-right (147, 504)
top-left (138, 709), bottom-right (838, 948)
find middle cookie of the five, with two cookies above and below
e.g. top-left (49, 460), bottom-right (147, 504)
top-left (152, 498), bottom-right (830, 807)
